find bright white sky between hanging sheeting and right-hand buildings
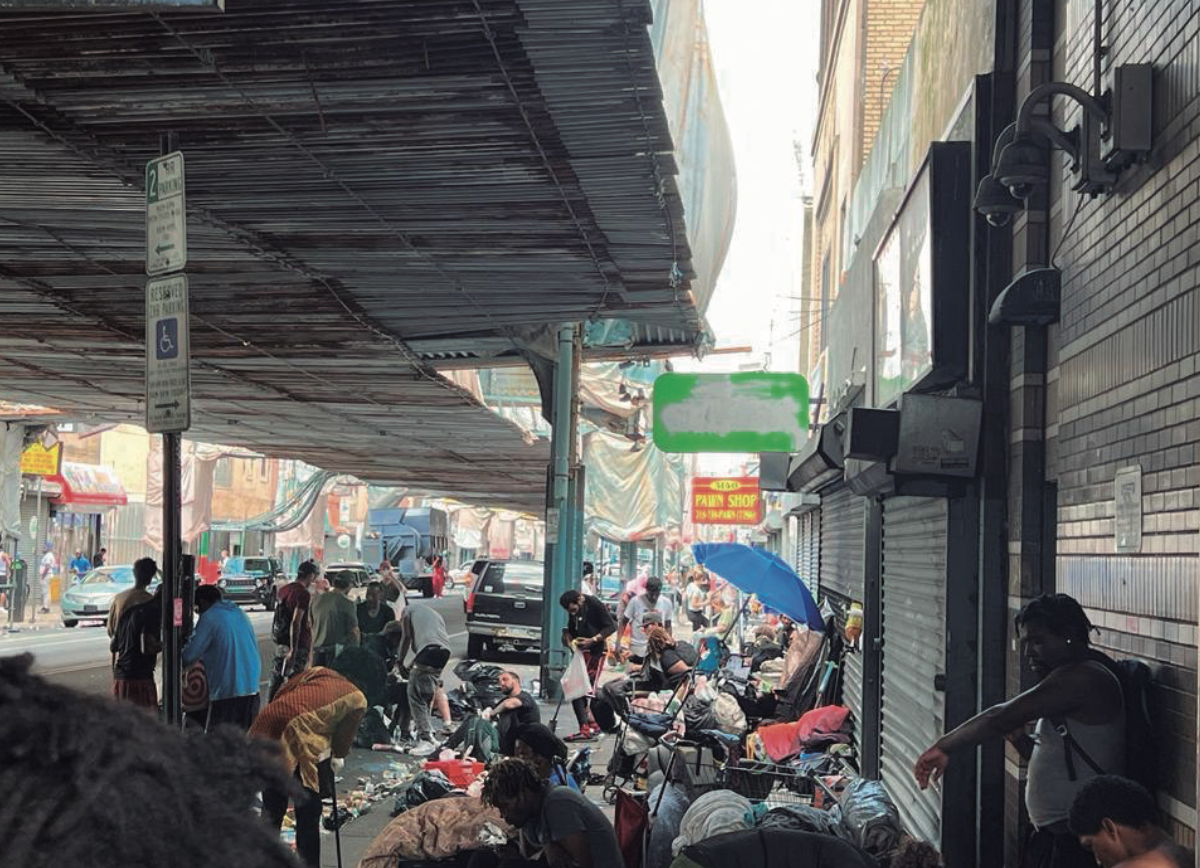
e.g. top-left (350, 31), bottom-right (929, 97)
top-left (678, 0), bottom-right (821, 371)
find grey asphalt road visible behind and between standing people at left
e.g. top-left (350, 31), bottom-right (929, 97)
top-left (0, 594), bottom-right (467, 694)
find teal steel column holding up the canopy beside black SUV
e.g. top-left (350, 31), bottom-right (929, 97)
top-left (540, 323), bottom-right (578, 699)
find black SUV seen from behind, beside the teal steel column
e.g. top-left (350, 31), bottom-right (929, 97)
top-left (463, 558), bottom-right (545, 660)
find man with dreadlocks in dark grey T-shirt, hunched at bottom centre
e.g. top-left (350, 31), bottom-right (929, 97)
top-left (484, 759), bottom-right (625, 868)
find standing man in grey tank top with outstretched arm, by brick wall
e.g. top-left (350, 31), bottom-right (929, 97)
top-left (913, 594), bottom-right (1126, 868)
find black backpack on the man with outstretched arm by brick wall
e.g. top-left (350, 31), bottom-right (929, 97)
top-left (1050, 651), bottom-right (1158, 794)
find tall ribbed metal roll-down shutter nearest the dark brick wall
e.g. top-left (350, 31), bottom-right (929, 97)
top-left (880, 497), bottom-right (947, 845)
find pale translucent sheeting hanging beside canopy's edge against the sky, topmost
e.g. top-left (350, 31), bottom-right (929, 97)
top-left (650, 0), bottom-right (737, 313)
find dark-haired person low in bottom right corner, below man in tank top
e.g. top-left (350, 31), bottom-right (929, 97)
top-left (1068, 774), bottom-right (1195, 868)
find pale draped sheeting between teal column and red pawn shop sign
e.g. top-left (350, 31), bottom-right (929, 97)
top-left (583, 431), bottom-right (685, 543)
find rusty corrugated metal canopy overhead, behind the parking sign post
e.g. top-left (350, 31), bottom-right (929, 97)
top-left (0, 0), bottom-right (703, 510)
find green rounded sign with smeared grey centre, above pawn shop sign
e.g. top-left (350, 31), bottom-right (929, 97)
top-left (654, 371), bottom-right (809, 453)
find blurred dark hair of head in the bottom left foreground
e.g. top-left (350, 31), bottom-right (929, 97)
top-left (0, 654), bottom-right (295, 868)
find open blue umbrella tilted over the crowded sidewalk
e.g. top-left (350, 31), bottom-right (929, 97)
top-left (691, 543), bottom-right (824, 630)
